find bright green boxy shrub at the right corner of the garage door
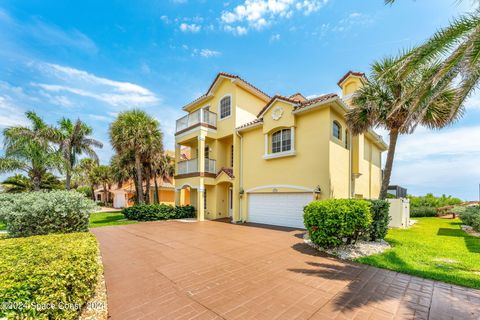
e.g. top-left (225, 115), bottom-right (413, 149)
top-left (303, 199), bottom-right (372, 248)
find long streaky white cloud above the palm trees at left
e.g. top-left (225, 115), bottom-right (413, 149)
top-left (31, 63), bottom-right (159, 107)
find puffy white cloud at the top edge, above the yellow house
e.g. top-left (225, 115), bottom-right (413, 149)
top-left (220, 0), bottom-right (328, 35)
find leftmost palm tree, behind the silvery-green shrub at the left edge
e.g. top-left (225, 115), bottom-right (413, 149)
top-left (0, 111), bottom-right (61, 191)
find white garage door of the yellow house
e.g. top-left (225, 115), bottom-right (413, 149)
top-left (248, 193), bottom-right (313, 229)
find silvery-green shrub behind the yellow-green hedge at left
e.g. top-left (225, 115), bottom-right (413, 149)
top-left (0, 191), bottom-right (96, 237)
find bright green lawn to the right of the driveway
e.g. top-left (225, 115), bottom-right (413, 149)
top-left (357, 218), bottom-right (480, 288)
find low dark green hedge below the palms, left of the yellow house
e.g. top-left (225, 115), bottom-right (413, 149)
top-left (122, 204), bottom-right (196, 221)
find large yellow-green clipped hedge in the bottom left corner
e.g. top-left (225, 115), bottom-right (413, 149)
top-left (0, 232), bottom-right (101, 320)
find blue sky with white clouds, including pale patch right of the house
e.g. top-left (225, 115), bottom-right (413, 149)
top-left (0, 0), bottom-right (480, 199)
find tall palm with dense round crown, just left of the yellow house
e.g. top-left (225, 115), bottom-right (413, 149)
top-left (110, 110), bottom-right (162, 203)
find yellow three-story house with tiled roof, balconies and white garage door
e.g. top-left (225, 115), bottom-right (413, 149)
top-left (175, 72), bottom-right (387, 227)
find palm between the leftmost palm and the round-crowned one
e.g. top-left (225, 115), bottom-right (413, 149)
top-left (57, 118), bottom-right (103, 190)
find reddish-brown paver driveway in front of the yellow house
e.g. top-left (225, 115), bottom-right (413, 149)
top-left (93, 221), bottom-right (480, 320)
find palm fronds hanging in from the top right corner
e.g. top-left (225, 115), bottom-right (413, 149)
top-left (385, 0), bottom-right (480, 112)
